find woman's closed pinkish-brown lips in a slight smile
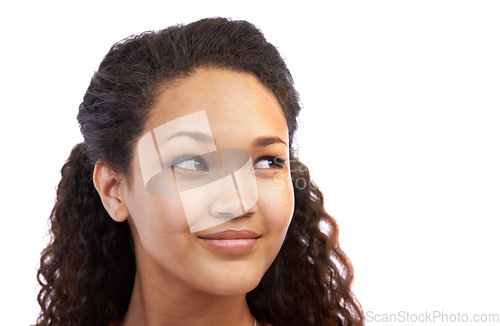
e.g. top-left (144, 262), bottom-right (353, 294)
top-left (198, 230), bottom-right (260, 254)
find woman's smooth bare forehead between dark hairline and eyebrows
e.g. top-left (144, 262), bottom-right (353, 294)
top-left (145, 69), bottom-right (288, 140)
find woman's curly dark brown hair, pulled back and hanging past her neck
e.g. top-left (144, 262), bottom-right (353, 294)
top-left (37, 18), bottom-right (364, 326)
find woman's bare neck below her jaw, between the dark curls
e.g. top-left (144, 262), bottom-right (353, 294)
top-left (121, 243), bottom-right (254, 326)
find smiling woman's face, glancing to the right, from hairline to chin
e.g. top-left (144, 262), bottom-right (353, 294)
top-left (124, 69), bottom-right (294, 295)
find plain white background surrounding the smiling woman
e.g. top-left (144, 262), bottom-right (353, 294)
top-left (0, 0), bottom-right (500, 325)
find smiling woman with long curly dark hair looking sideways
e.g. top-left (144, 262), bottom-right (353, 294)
top-left (37, 18), bottom-right (363, 326)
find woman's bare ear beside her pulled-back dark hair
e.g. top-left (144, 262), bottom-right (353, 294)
top-left (93, 162), bottom-right (129, 222)
